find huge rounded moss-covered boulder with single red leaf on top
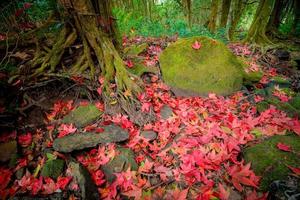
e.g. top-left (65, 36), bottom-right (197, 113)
top-left (159, 37), bottom-right (244, 96)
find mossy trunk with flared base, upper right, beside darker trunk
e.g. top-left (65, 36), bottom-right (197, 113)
top-left (245, 0), bottom-right (275, 45)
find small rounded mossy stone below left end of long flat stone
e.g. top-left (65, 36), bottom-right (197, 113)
top-left (41, 159), bottom-right (65, 179)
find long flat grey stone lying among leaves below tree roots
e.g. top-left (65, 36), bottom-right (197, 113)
top-left (53, 125), bottom-right (129, 153)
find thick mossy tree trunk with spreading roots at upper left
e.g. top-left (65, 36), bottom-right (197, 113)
top-left (33, 0), bottom-right (139, 95)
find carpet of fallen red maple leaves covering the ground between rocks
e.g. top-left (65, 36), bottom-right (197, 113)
top-left (0, 38), bottom-right (300, 200)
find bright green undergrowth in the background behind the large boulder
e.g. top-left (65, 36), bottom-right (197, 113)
top-left (114, 7), bottom-right (228, 42)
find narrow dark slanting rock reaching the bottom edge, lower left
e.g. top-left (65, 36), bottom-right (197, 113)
top-left (69, 162), bottom-right (100, 200)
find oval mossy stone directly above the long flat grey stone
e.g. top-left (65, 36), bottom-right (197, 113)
top-left (62, 104), bottom-right (102, 128)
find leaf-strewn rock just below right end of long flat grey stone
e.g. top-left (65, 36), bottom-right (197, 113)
top-left (101, 148), bottom-right (138, 183)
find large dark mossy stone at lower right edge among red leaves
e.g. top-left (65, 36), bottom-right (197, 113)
top-left (244, 134), bottom-right (300, 191)
